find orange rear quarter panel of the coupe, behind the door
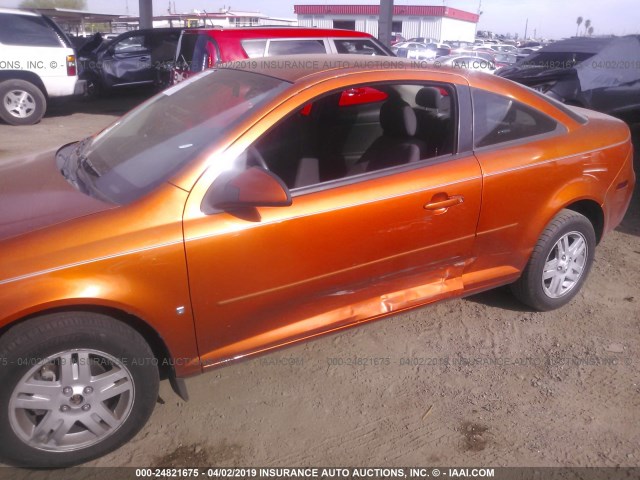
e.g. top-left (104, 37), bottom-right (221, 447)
top-left (470, 103), bottom-right (634, 282)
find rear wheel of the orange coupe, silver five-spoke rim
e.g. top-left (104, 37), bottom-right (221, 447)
top-left (511, 210), bottom-right (596, 312)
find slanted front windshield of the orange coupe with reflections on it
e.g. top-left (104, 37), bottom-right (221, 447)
top-left (59, 69), bottom-right (289, 204)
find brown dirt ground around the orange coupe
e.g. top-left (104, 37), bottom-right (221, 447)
top-left (0, 96), bottom-right (640, 467)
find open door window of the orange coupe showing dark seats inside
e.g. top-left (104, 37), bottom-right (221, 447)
top-left (249, 84), bottom-right (456, 189)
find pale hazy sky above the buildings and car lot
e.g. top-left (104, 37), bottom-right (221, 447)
top-left (0, 0), bottom-right (640, 39)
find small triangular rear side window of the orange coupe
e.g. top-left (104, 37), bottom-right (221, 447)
top-left (472, 89), bottom-right (558, 148)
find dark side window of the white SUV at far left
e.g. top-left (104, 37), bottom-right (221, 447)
top-left (0, 13), bottom-right (62, 47)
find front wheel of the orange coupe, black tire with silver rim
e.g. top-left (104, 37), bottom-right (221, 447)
top-left (0, 312), bottom-right (159, 468)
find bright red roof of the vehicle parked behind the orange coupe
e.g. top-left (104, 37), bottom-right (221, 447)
top-left (184, 26), bottom-right (371, 38)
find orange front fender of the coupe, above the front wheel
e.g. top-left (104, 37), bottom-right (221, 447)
top-left (0, 184), bottom-right (200, 376)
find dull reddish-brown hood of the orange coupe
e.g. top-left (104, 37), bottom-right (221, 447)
top-left (0, 151), bottom-right (116, 241)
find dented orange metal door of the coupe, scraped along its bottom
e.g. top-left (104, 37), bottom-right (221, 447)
top-left (184, 82), bottom-right (482, 366)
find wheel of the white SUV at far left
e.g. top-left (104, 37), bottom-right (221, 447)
top-left (0, 80), bottom-right (47, 125)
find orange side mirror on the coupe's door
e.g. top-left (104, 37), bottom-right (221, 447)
top-left (201, 167), bottom-right (291, 214)
